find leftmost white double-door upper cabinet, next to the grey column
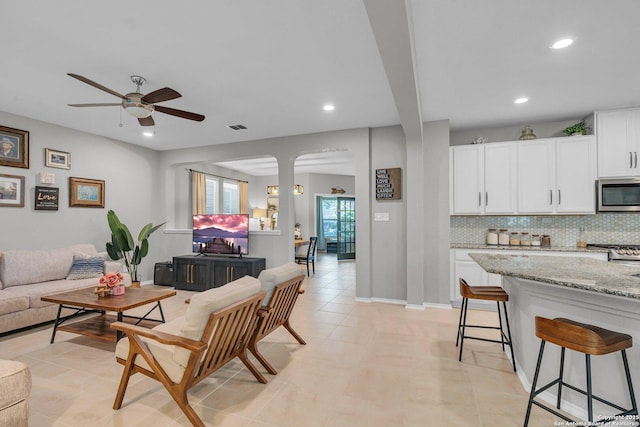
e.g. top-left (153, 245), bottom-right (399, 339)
top-left (449, 143), bottom-right (516, 215)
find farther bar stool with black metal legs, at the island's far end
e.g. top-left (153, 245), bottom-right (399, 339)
top-left (456, 277), bottom-right (516, 372)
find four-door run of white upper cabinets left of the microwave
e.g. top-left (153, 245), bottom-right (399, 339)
top-left (450, 136), bottom-right (596, 215)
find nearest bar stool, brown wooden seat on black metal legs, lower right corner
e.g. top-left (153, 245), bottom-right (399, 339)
top-left (524, 316), bottom-right (638, 427)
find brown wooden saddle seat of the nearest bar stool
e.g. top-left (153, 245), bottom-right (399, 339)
top-left (536, 317), bottom-right (633, 356)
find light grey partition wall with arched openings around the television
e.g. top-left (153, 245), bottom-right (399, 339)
top-left (160, 129), bottom-right (371, 297)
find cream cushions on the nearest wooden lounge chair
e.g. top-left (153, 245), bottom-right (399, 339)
top-left (116, 276), bottom-right (260, 382)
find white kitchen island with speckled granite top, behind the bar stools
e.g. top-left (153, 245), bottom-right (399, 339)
top-left (471, 253), bottom-right (640, 419)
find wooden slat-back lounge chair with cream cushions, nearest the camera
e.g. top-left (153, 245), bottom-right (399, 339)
top-left (112, 276), bottom-right (267, 426)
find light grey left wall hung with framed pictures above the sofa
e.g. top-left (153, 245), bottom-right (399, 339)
top-left (0, 112), bottom-right (164, 280)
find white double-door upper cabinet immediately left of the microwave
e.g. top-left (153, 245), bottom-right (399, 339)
top-left (517, 136), bottom-right (596, 214)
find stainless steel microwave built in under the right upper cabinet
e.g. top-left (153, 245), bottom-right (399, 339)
top-left (596, 178), bottom-right (640, 212)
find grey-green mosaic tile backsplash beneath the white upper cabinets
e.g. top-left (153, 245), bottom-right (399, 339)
top-left (450, 213), bottom-right (640, 246)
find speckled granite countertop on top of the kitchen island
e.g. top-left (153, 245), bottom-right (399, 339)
top-left (470, 253), bottom-right (640, 299)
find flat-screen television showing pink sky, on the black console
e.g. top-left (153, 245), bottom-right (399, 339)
top-left (193, 214), bottom-right (249, 255)
